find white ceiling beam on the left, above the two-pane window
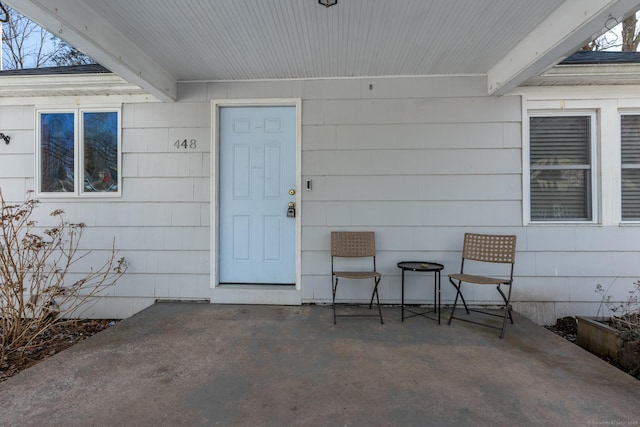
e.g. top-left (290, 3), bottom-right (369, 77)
top-left (7, 0), bottom-right (178, 101)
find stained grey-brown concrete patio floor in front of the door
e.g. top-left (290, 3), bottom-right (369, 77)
top-left (0, 303), bottom-right (640, 426)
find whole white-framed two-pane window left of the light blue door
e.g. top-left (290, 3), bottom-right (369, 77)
top-left (36, 109), bottom-right (121, 197)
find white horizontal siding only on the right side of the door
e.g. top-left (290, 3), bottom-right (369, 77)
top-left (284, 79), bottom-right (640, 321)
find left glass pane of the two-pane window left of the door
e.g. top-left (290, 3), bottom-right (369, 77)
top-left (40, 113), bottom-right (75, 192)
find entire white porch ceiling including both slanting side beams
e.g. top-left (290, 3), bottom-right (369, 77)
top-left (7, 0), bottom-right (640, 100)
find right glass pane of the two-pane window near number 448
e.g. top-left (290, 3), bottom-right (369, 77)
top-left (82, 111), bottom-right (120, 192)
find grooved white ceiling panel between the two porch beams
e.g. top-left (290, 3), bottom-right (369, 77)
top-left (81, 0), bottom-right (563, 81)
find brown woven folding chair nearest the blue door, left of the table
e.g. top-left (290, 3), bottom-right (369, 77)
top-left (331, 231), bottom-right (384, 325)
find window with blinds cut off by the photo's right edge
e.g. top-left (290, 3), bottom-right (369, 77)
top-left (620, 114), bottom-right (640, 221)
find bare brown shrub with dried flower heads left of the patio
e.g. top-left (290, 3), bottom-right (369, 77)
top-left (0, 192), bottom-right (127, 366)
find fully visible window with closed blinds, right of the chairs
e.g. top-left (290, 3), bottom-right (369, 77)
top-left (529, 115), bottom-right (593, 221)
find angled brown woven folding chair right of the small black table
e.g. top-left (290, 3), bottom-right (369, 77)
top-left (448, 233), bottom-right (516, 338)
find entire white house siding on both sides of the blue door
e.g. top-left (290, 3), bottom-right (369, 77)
top-left (0, 77), bottom-right (640, 320)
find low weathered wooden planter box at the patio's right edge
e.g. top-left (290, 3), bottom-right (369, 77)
top-left (576, 316), bottom-right (640, 374)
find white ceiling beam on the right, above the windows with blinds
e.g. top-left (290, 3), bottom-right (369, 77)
top-left (487, 0), bottom-right (640, 95)
